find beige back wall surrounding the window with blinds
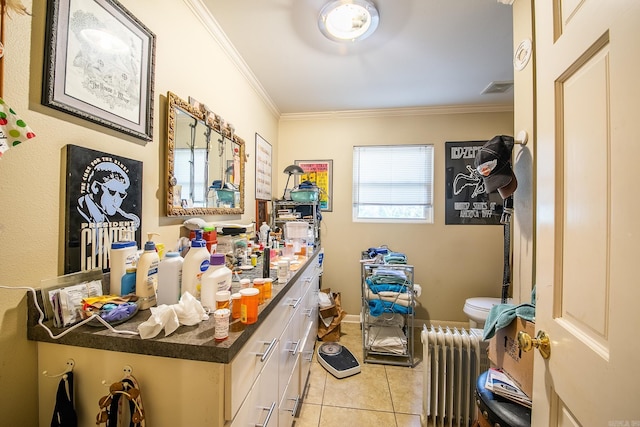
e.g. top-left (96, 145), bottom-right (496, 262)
top-left (274, 110), bottom-right (513, 321)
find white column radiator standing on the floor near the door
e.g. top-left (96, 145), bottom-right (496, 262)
top-left (420, 325), bottom-right (489, 427)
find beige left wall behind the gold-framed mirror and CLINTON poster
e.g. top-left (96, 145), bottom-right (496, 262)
top-left (0, 0), bottom-right (277, 426)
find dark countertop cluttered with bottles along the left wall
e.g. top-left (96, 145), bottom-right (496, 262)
top-left (27, 250), bottom-right (320, 363)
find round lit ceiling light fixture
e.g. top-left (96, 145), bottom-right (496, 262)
top-left (318, 0), bottom-right (380, 42)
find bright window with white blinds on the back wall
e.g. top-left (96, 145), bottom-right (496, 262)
top-left (353, 145), bottom-right (433, 223)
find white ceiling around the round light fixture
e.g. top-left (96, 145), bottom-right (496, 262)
top-left (200, 0), bottom-right (513, 114)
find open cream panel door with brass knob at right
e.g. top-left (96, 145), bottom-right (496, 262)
top-left (532, 0), bottom-right (640, 427)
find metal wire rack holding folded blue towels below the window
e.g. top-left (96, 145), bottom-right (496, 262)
top-left (360, 262), bottom-right (415, 367)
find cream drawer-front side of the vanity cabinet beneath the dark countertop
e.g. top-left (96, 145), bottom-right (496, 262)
top-left (227, 261), bottom-right (320, 427)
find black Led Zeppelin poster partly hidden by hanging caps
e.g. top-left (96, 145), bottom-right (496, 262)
top-left (445, 141), bottom-right (502, 225)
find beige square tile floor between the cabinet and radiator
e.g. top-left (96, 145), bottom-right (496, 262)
top-left (294, 322), bottom-right (423, 427)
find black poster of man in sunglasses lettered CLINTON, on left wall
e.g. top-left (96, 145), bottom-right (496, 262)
top-left (64, 145), bottom-right (142, 274)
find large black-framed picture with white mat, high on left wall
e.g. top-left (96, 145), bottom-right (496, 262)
top-left (42, 0), bottom-right (155, 141)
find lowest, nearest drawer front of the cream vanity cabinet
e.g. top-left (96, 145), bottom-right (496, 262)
top-left (231, 344), bottom-right (278, 427)
